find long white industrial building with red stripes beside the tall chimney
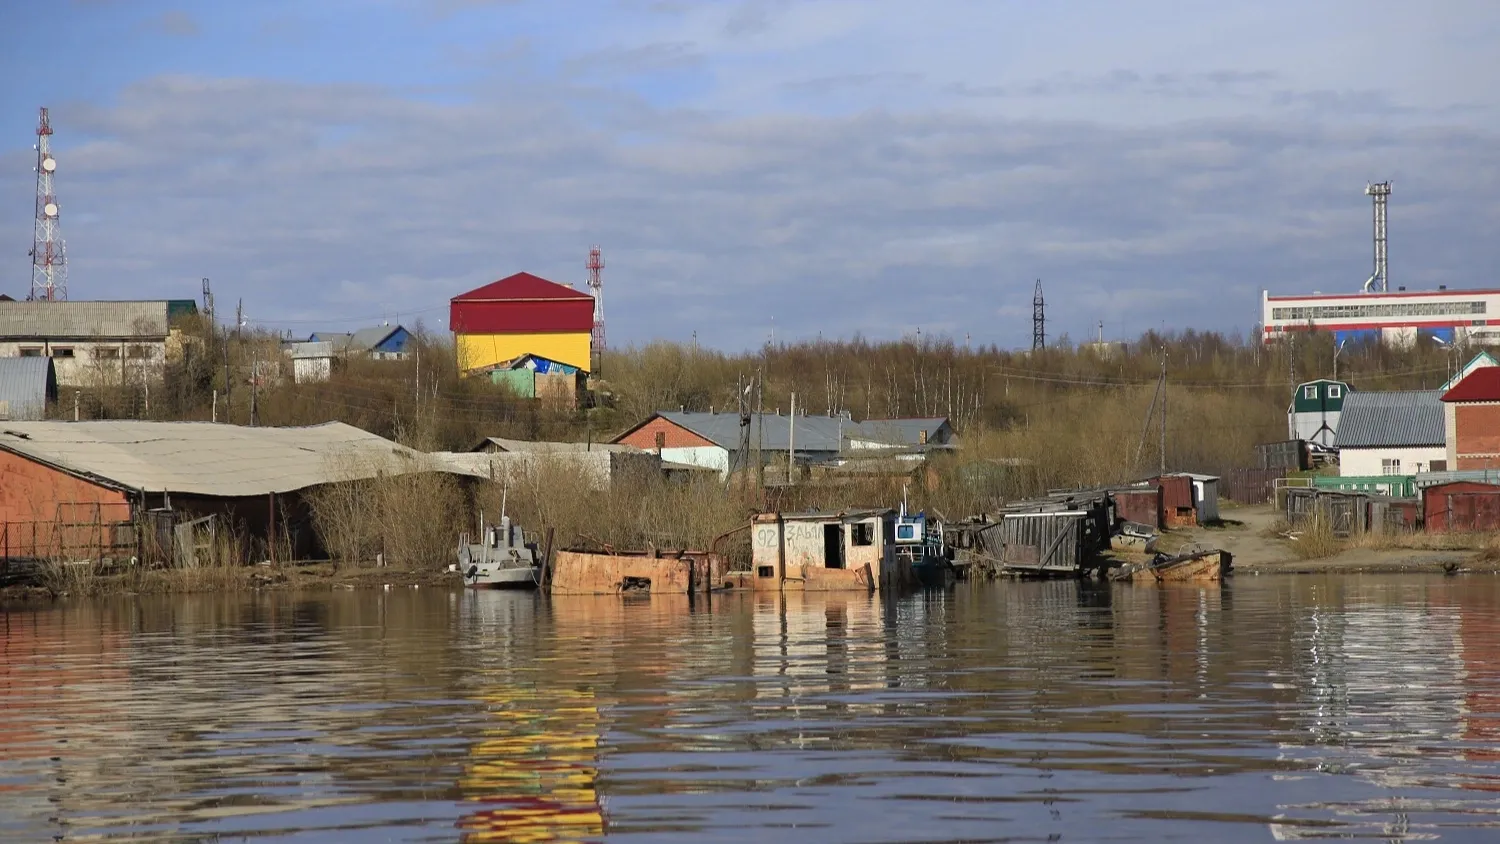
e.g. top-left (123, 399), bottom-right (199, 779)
top-left (1260, 288), bottom-right (1500, 346)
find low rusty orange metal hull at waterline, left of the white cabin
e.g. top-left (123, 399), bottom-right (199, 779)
top-left (552, 550), bottom-right (726, 595)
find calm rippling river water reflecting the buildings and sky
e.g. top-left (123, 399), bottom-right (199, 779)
top-left (0, 576), bottom-right (1500, 843)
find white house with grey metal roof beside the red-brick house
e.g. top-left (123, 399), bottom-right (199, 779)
top-left (1335, 390), bottom-right (1448, 477)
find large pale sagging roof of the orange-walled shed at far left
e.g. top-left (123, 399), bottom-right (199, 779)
top-left (0, 421), bottom-right (432, 498)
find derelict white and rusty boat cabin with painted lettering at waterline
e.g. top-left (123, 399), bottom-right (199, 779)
top-left (750, 510), bottom-right (926, 591)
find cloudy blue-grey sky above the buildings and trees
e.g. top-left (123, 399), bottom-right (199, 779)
top-left (0, 0), bottom-right (1500, 349)
